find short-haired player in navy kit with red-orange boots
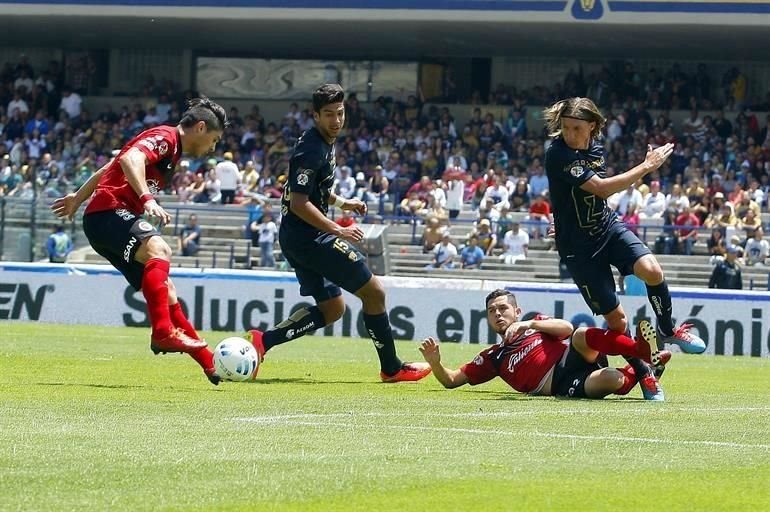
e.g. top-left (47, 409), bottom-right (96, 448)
top-left (248, 84), bottom-right (430, 382)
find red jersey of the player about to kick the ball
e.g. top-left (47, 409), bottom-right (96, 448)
top-left (86, 126), bottom-right (182, 215)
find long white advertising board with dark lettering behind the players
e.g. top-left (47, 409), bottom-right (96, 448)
top-left (0, 263), bottom-right (770, 357)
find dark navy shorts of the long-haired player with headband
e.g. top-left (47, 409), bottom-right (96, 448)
top-left (563, 226), bottom-right (652, 315)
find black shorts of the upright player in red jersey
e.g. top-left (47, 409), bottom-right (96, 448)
top-left (83, 209), bottom-right (160, 290)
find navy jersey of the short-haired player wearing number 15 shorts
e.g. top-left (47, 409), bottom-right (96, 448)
top-left (281, 128), bottom-right (335, 236)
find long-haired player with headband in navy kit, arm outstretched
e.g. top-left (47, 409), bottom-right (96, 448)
top-left (543, 98), bottom-right (706, 400)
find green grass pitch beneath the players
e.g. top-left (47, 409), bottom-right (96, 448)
top-left (0, 322), bottom-right (770, 512)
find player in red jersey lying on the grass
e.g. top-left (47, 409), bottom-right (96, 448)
top-left (420, 290), bottom-right (671, 401)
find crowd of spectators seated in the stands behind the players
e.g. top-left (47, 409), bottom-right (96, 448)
top-left (0, 58), bottom-right (770, 268)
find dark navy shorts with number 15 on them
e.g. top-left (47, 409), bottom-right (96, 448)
top-left (279, 227), bottom-right (372, 302)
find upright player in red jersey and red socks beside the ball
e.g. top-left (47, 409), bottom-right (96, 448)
top-left (52, 98), bottom-right (227, 384)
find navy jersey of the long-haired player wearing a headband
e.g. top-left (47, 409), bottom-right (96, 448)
top-left (545, 137), bottom-right (622, 258)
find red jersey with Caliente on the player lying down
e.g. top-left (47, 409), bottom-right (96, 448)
top-left (460, 315), bottom-right (569, 393)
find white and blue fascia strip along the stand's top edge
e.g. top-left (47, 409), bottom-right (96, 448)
top-left (0, 0), bottom-right (770, 26)
